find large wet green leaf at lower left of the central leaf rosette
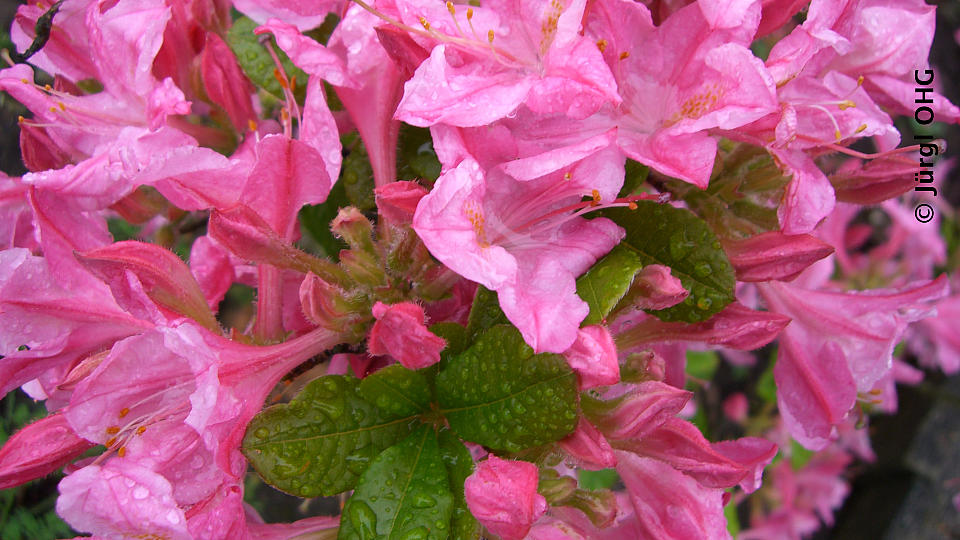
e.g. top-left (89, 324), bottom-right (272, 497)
top-left (242, 375), bottom-right (417, 497)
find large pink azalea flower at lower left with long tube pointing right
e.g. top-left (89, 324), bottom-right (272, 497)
top-left (58, 323), bottom-right (336, 535)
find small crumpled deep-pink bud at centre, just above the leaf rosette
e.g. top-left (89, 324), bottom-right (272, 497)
top-left (367, 302), bottom-right (447, 369)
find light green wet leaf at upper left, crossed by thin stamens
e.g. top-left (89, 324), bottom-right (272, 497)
top-left (227, 17), bottom-right (307, 102)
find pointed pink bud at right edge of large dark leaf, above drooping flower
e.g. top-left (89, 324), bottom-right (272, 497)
top-left (724, 231), bottom-right (833, 281)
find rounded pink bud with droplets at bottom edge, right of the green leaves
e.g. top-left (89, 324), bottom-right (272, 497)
top-left (463, 455), bottom-right (547, 540)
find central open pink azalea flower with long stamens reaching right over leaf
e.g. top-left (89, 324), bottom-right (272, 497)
top-left (413, 129), bottom-right (623, 353)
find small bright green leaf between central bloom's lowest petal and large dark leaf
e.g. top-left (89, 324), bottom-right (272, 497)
top-left (577, 246), bottom-right (643, 325)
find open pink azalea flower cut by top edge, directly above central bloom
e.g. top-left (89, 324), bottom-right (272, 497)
top-left (396, 0), bottom-right (620, 127)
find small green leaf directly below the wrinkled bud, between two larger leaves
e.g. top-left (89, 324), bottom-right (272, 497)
top-left (357, 364), bottom-right (430, 416)
